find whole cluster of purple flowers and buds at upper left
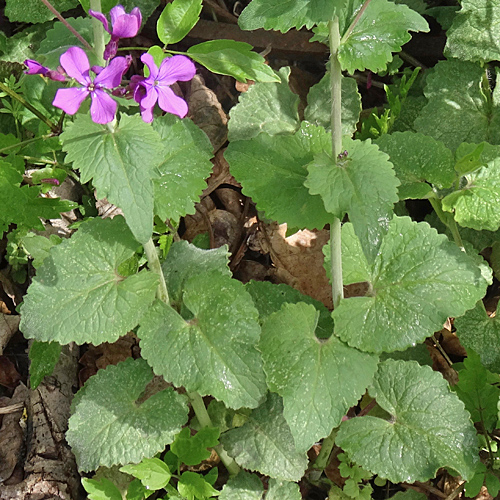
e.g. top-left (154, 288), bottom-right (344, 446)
top-left (24, 5), bottom-right (196, 124)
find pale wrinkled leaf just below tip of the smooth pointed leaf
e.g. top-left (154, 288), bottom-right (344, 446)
top-left (228, 66), bottom-right (300, 141)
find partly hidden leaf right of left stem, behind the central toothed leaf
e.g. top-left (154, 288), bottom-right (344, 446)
top-left (162, 241), bottom-right (232, 306)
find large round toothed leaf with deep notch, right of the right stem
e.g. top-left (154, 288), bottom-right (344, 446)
top-left (332, 217), bottom-right (487, 352)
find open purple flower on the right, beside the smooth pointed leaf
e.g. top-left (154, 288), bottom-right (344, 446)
top-left (134, 54), bottom-right (196, 122)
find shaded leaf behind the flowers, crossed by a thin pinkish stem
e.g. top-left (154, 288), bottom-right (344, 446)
top-left (36, 17), bottom-right (98, 69)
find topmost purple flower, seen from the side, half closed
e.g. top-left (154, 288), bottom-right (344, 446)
top-left (89, 5), bottom-right (142, 61)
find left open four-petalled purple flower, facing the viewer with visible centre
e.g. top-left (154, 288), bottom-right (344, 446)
top-left (52, 47), bottom-right (130, 123)
